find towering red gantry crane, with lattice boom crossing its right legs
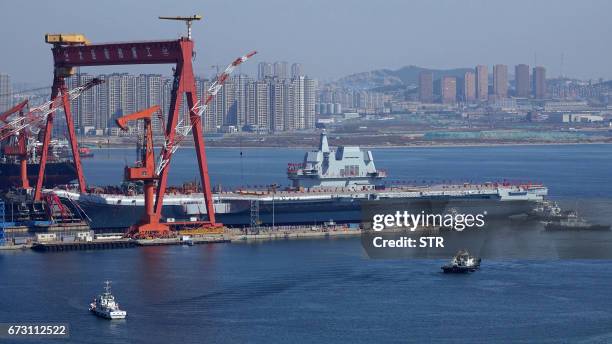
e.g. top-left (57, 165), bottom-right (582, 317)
top-left (40, 15), bottom-right (255, 235)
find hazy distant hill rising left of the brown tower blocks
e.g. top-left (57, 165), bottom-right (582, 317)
top-left (336, 66), bottom-right (473, 89)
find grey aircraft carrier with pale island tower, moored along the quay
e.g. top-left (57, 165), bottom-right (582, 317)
top-left (48, 132), bottom-right (548, 228)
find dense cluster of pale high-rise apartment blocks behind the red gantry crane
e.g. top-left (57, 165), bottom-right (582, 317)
top-left (44, 68), bottom-right (316, 135)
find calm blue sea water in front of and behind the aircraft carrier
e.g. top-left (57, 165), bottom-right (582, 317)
top-left (0, 145), bottom-right (612, 343)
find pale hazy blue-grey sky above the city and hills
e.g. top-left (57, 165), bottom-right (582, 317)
top-left (0, 0), bottom-right (612, 85)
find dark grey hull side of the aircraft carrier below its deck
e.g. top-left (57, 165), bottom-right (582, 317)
top-left (68, 197), bottom-right (536, 229)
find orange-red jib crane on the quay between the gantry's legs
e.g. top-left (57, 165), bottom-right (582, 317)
top-left (116, 105), bottom-right (170, 238)
